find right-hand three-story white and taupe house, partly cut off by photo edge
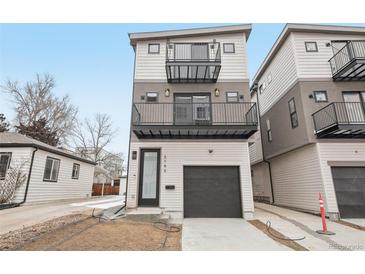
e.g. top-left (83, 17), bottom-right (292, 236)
top-left (250, 24), bottom-right (365, 219)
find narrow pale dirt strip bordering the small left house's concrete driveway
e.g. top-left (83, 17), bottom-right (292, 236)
top-left (0, 214), bottom-right (89, 250)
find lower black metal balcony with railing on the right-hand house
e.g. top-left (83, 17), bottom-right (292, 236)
top-left (312, 102), bottom-right (365, 138)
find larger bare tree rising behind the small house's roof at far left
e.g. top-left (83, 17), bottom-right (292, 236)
top-left (1, 74), bottom-right (77, 144)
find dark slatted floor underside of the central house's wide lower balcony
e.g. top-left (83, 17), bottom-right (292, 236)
top-left (133, 125), bottom-right (257, 139)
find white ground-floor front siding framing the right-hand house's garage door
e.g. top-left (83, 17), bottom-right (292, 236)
top-left (317, 142), bottom-right (365, 215)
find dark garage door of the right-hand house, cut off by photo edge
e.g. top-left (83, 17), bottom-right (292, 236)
top-left (332, 167), bottom-right (365, 218)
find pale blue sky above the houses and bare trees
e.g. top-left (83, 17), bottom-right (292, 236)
top-left (0, 24), bottom-right (365, 155)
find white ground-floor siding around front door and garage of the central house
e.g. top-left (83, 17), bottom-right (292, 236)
top-left (127, 142), bottom-right (254, 216)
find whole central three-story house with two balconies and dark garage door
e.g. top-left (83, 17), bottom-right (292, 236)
top-left (127, 25), bottom-right (257, 218)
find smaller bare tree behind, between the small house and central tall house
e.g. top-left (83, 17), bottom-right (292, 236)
top-left (74, 113), bottom-right (123, 170)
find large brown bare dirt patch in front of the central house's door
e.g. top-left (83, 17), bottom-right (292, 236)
top-left (12, 217), bottom-right (181, 251)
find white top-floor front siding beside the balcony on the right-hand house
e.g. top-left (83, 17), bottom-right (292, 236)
top-left (292, 33), bottom-right (365, 78)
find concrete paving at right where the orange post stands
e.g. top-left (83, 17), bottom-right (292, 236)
top-left (254, 203), bottom-right (365, 250)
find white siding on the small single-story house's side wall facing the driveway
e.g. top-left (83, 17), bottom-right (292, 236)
top-left (22, 150), bottom-right (94, 203)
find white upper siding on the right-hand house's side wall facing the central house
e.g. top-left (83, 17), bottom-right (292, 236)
top-left (258, 35), bottom-right (297, 115)
